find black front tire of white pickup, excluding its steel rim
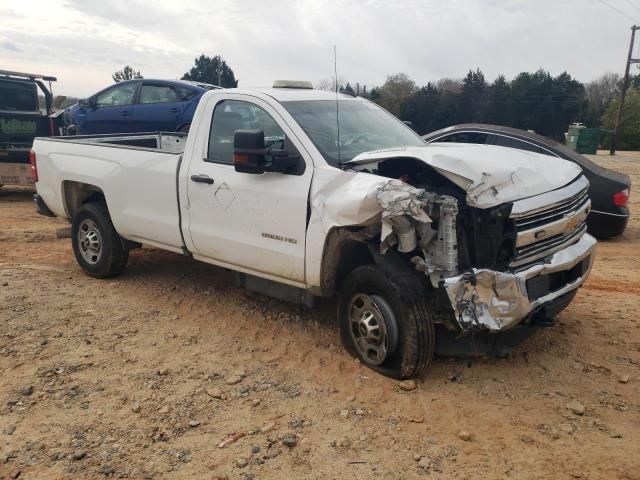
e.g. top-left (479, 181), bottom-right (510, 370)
top-left (338, 265), bottom-right (435, 379)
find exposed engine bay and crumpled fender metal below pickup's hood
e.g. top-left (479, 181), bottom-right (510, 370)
top-left (358, 158), bottom-right (515, 280)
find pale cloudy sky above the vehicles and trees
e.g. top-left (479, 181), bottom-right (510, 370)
top-left (0, 0), bottom-right (640, 97)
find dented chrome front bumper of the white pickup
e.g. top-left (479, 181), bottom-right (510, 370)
top-left (444, 234), bottom-right (596, 332)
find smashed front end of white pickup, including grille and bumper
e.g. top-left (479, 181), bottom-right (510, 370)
top-left (377, 172), bottom-right (596, 333)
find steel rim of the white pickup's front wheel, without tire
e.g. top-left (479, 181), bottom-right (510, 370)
top-left (349, 293), bottom-right (396, 365)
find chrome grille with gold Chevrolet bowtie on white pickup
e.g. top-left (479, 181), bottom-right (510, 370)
top-left (510, 176), bottom-right (591, 267)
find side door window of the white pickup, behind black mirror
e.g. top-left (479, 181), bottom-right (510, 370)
top-left (207, 100), bottom-right (285, 164)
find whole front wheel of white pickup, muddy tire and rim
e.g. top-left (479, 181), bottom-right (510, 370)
top-left (338, 265), bottom-right (435, 379)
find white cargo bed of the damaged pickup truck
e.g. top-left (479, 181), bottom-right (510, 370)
top-left (34, 132), bottom-right (186, 252)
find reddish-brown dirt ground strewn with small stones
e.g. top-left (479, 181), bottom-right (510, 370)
top-left (0, 155), bottom-right (640, 480)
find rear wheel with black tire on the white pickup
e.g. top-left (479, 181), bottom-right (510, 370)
top-left (71, 203), bottom-right (129, 278)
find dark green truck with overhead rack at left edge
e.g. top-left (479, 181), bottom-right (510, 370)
top-left (0, 70), bottom-right (56, 186)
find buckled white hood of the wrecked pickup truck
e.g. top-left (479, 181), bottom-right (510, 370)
top-left (348, 143), bottom-right (582, 208)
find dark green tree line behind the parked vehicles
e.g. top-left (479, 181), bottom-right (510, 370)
top-left (113, 59), bottom-right (640, 149)
